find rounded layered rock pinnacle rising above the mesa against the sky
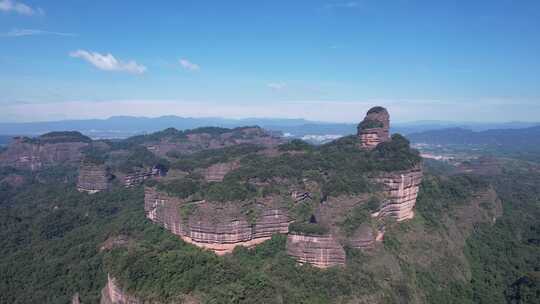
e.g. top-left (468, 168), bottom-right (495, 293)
top-left (357, 107), bottom-right (390, 149)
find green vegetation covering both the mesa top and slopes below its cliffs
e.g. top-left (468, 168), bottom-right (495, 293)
top-left (0, 127), bottom-right (540, 303)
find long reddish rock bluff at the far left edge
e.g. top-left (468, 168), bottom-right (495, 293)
top-left (0, 138), bottom-right (88, 170)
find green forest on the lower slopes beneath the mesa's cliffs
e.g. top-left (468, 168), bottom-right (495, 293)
top-left (0, 151), bottom-right (540, 303)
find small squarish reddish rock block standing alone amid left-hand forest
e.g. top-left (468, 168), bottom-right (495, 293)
top-left (77, 162), bottom-right (110, 194)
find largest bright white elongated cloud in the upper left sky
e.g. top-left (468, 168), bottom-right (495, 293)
top-left (69, 50), bottom-right (146, 74)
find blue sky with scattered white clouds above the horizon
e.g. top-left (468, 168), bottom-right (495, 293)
top-left (0, 0), bottom-right (540, 122)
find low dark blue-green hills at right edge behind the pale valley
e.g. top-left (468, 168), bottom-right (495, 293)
top-left (408, 126), bottom-right (540, 149)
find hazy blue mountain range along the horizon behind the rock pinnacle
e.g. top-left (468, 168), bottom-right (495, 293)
top-left (0, 116), bottom-right (539, 144)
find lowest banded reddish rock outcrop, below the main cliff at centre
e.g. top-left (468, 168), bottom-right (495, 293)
top-left (287, 233), bottom-right (345, 268)
